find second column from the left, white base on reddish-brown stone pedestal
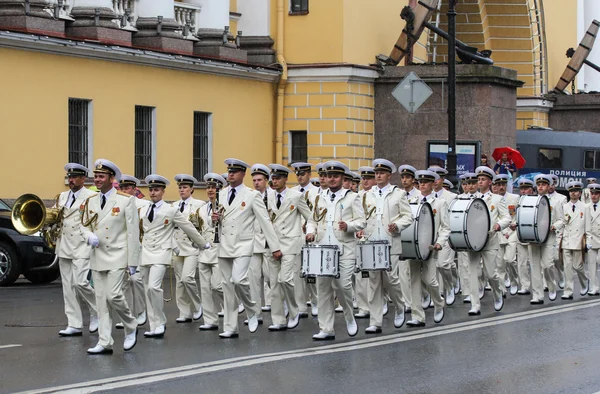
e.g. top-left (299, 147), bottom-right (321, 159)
top-left (66, 0), bottom-right (131, 46)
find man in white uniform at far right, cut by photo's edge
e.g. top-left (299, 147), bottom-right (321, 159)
top-left (584, 183), bottom-right (600, 296)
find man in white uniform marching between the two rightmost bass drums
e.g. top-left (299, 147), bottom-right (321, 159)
top-left (493, 174), bottom-right (519, 295)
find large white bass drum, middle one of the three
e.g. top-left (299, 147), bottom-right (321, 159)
top-left (450, 198), bottom-right (491, 252)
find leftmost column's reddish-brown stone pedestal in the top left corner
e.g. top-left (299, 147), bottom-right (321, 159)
top-left (0, 0), bottom-right (65, 35)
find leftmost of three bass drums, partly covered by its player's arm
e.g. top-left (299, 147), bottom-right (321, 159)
top-left (400, 202), bottom-right (435, 261)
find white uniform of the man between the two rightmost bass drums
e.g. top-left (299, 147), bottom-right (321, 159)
top-left (498, 192), bottom-right (519, 288)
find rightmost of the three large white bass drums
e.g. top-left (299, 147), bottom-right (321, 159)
top-left (517, 196), bottom-right (550, 244)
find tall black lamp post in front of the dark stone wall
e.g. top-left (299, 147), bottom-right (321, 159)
top-left (446, 0), bottom-right (459, 191)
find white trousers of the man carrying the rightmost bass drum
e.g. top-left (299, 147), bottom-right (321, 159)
top-left (529, 233), bottom-right (558, 300)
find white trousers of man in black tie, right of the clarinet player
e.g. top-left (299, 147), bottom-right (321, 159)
top-left (219, 256), bottom-right (260, 333)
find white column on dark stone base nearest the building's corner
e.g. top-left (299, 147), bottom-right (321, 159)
top-left (238, 0), bottom-right (276, 64)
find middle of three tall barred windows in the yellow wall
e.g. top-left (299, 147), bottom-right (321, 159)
top-left (134, 105), bottom-right (156, 179)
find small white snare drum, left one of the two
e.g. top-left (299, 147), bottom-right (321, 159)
top-left (300, 245), bottom-right (340, 278)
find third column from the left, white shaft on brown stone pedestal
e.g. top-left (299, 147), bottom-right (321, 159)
top-left (132, 0), bottom-right (193, 55)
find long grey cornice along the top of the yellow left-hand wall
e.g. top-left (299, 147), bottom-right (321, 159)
top-left (0, 31), bottom-right (281, 83)
